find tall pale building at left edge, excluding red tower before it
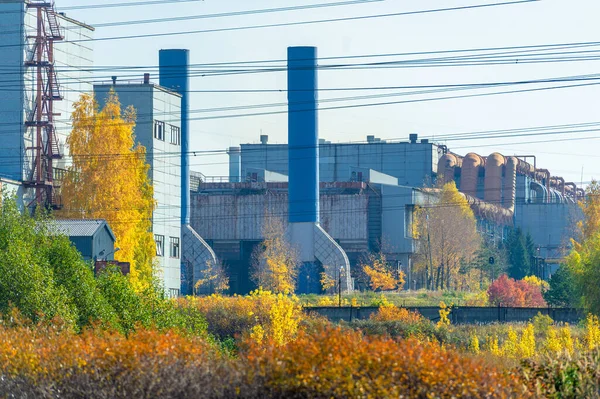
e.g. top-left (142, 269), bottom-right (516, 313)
top-left (0, 0), bottom-right (94, 203)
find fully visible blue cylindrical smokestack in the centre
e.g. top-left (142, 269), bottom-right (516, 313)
top-left (288, 47), bottom-right (319, 223)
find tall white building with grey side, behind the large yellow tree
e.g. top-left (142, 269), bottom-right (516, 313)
top-left (94, 76), bottom-right (181, 296)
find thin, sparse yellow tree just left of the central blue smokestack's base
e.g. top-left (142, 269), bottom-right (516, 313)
top-left (251, 216), bottom-right (300, 293)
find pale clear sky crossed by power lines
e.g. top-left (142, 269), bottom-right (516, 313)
top-left (57, 0), bottom-right (600, 185)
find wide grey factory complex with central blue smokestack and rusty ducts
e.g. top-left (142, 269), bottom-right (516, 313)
top-left (191, 48), bottom-right (584, 293)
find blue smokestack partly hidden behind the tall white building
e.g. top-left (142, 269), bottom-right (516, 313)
top-left (158, 49), bottom-right (190, 224)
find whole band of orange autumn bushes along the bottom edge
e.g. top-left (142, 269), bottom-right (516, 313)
top-left (0, 323), bottom-right (526, 398)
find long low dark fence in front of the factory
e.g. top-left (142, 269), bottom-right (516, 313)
top-left (304, 306), bottom-right (585, 324)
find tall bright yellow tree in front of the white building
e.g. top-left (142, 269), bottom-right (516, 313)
top-left (58, 91), bottom-right (156, 291)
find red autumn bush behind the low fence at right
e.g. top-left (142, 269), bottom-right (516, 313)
top-left (488, 274), bottom-right (546, 307)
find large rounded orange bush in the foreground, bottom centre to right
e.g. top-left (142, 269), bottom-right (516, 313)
top-left (248, 327), bottom-right (522, 398)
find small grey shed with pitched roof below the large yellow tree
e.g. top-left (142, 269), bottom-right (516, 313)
top-left (52, 219), bottom-right (118, 261)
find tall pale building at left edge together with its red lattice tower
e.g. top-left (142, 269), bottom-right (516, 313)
top-left (0, 0), bottom-right (94, 207)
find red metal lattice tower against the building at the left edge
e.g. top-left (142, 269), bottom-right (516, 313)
top-left (24, 0), bottom-right (64, 208)
